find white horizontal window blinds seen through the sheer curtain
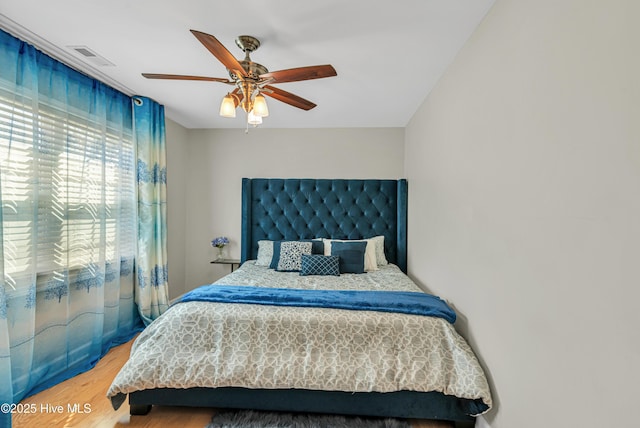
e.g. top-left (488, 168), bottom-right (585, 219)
top-left (0, 89), bottom-right (136, 290)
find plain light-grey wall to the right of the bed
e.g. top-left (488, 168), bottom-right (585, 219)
top-left (405, 0), bottom-right (640, 428)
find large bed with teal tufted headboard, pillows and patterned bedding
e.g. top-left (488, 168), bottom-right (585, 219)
top-left (107, 178), bottom-right (491, 423)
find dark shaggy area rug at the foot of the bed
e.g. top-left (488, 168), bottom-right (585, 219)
top-left (206, 410), bottom-right (411, 428)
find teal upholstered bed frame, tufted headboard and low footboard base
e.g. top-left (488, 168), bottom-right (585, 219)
top-left (129, 178), bottom-right (486, 427)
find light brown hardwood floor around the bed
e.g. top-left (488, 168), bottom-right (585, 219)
top-left (13, 341), bottom-right (452, 428)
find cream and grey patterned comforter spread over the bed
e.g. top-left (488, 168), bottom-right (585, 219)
top-left (107, 261), bottom-right (492, 414)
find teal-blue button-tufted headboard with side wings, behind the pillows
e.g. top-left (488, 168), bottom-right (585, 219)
top-left (241, 178), bottom-right (407, 273)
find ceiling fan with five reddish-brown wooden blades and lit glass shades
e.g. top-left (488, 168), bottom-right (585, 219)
top-left (142, 30), bottom-right (337, 125)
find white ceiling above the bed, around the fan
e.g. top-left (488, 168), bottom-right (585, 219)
top-left (0, 0), bottom-right (494, 128)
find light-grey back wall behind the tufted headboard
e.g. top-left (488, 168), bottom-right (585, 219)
top-left (179, 128), bottom-right (404, 295)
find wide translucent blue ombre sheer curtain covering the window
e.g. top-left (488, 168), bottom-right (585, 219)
top-left (0, 31), bottom-right (142, 426)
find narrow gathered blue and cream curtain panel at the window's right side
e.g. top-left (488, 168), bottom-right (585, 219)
top-left (133, 96), bottom-right (169, 324)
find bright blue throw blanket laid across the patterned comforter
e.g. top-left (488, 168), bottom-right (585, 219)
top-left (178, 285), bottom-right (456, 324)
